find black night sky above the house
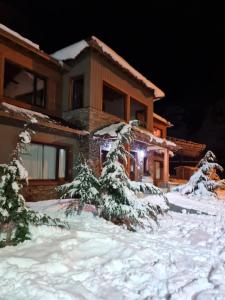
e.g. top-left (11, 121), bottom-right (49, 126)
top-left (0, 0), bottom-right (225, 164)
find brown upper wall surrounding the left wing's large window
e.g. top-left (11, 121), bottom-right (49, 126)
top-left (0, 43), bottom-right (62, 116)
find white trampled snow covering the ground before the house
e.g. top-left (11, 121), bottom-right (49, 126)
top-left (0, 193), bottom-right (225, 300)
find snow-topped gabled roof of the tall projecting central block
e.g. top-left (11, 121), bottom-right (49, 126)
top-left (52, 36), bottom-right (165, 99)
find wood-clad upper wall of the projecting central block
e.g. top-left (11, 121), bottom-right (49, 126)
top-left (63, 49), bottom-right (156, 131)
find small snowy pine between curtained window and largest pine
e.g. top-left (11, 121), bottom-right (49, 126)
top-left (59, 158), bottom-right (100, 216)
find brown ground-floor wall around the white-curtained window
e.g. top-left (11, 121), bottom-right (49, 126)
top-left (0, 123), bottom-right (81, 201)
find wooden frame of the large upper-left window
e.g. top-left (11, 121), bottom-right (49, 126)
top-left (3, 58), bottom-right (47, 109)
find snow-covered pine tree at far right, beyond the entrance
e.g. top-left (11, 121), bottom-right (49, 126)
top-left (174, 151), bottom-right (225, 197)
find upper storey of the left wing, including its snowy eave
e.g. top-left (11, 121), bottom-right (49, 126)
top-left (0, 25), bottom-right (65, 117)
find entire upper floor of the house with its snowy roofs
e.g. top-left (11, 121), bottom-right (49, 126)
top-left (0, 25), bottom-right (170, 138)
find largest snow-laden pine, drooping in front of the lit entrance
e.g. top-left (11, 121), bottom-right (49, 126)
top-left (96, 122), bottom-right (166, 230)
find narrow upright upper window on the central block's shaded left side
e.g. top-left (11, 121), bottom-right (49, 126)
top-left (72, 76), bottom-right (84, 109)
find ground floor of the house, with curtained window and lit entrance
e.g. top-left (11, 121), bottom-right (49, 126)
top-left (0, 105), bottom-right (178, 201)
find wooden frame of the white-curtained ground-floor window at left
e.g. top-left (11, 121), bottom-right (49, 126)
top-left (22, 141), bottom-right (69, 182)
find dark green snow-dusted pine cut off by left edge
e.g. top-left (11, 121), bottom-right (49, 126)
top-left (0, 120), bottom-right (67, 247)
